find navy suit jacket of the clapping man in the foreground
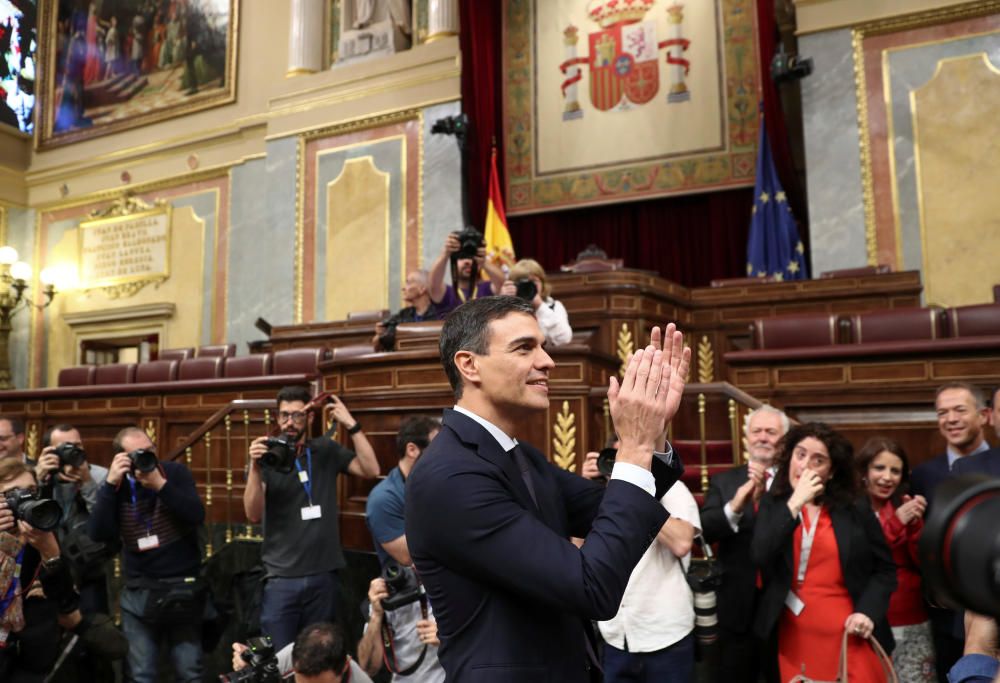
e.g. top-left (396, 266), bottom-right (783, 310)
top-left (406, 410), bottom-right (668, 683)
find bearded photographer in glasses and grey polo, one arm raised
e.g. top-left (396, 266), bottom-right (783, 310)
top-left (243, 387), bottom-right (379, 649)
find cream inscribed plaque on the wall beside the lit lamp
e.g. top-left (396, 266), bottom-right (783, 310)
top-left (79, 205), bottom-right (170, 289)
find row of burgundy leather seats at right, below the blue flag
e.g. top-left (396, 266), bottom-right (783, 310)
top-left (744, 304), bottom-right (1000, 360)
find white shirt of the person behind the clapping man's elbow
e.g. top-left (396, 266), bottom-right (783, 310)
top-left (598, 482), bottom-right (701, 652)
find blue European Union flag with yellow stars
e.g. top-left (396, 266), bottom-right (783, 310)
top-left (747, 119), bottom-right (809, 282)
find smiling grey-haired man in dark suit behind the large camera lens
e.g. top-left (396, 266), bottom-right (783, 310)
top-left (910, 382), bottom-right (990, 683)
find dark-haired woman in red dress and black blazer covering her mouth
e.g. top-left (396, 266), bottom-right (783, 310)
top-left (751, 422), bottom-right (896, 681)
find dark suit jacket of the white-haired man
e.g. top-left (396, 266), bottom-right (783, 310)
top-left (701, 465), bottom-right (757, 633)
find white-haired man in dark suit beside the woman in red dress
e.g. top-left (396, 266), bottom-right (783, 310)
top-left (701, 405), bottom-right (788, 683)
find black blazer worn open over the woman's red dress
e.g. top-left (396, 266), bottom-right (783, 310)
top-left (751, 495), bottom-right (896, 652)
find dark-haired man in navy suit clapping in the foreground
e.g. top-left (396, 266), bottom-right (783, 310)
top-left (406, 296), bottom-right (690, 683)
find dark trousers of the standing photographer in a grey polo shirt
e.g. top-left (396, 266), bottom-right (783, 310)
top-left (260, 572), bottom-right (340, 650)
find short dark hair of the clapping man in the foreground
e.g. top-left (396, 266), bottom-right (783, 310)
top-left (438, 296), bottom-right (535, 399)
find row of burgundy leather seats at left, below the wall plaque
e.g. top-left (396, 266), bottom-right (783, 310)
top-left (58, 348), bottom-right (330, 387)
